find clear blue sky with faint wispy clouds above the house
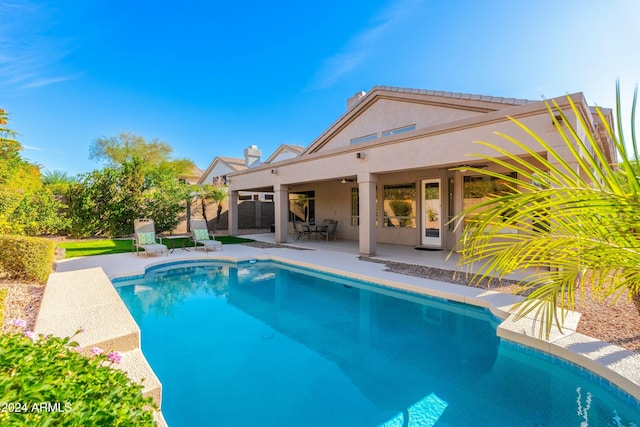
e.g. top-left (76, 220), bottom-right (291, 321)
top-left (0, 0), bottom-right (640, 175)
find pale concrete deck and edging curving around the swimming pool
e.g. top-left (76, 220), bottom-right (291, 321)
top-left (36, 241), bottom-right (640, 422)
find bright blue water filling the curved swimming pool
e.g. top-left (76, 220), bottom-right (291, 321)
top-left (114, 262), bottom-right (640, 427)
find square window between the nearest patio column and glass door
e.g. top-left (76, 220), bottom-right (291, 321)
top-left (383, 184), bottom-right (416, 228)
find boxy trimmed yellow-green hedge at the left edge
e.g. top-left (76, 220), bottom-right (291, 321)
top-left (0, 235), bottom-right (56, 283)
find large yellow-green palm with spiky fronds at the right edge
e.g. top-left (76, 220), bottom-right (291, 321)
top-left (455, 83), bottom-right (640, 338)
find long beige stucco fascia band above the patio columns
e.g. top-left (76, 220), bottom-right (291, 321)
top-left (230, 105), bottom-right (559, 190)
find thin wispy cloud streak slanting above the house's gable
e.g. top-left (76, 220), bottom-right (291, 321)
top-left (310, 0), bottom-right (422, 89)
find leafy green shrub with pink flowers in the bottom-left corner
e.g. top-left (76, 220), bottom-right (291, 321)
top-left (0, 321), bottom-right (156, 426)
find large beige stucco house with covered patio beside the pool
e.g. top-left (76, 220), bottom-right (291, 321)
top-left (228, 86), bottom-right (616, 255)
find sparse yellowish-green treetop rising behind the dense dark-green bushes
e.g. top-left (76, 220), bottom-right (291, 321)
top-left (89, 132), bottom-right (194, 174)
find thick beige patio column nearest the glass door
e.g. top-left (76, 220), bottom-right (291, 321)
top-left (358, 173), bottom-right (377, 256)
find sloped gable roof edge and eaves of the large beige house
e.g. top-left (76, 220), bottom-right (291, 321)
top-left (302, 86), bottom-right (539, 155)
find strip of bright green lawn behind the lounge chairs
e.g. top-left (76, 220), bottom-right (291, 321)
top-left (58, 236), bottom-right (253, 258)
